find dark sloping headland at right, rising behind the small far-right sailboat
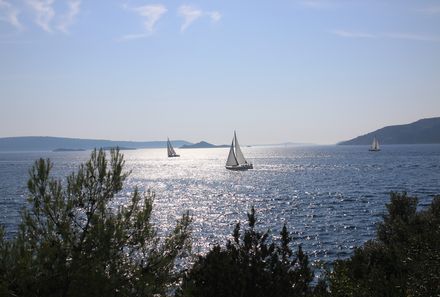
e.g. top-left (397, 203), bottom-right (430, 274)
top-left (338, 117), bottom-right (440, 145)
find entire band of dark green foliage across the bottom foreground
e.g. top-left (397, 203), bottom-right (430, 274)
top-left (0, 150), bottom-right (440, 297)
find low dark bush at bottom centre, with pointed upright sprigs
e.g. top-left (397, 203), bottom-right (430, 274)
top-left (179, 208), bottom-right (313, 297)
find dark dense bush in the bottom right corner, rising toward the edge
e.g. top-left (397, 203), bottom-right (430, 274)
top-left (329, 193), bottom-right (440, 296)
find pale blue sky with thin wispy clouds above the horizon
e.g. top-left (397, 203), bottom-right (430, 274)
top-left (0, 0), bottom-right (440, 144)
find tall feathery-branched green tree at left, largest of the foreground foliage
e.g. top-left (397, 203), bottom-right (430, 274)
top-left (0, 150), bottom-right (191, 296)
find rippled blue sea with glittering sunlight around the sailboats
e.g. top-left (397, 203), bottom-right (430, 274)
top-left (0, 145), bottom-right (440, 261)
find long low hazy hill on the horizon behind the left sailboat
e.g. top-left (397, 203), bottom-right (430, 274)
top-left (0, 136), bottom-right (191, 151)
